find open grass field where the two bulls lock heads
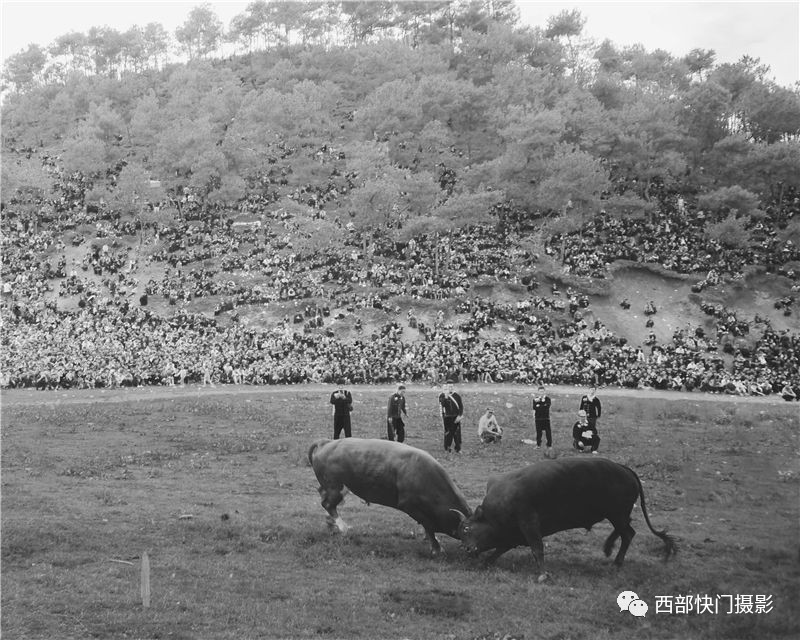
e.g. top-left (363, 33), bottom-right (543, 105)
top-left (2, 385), bottom-right (800, 640)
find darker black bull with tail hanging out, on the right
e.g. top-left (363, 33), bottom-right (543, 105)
top-left (458, 457), bottom-right (677, 571)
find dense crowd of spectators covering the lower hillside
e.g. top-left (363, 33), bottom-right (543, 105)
top-left (0, 149), bottom-right (800, 395)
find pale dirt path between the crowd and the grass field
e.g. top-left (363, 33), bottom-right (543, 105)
top-left (0, 383), bottom-right (800, 408)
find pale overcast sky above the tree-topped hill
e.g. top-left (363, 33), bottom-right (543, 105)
top-left (0, 0), bottom-right (800, 87)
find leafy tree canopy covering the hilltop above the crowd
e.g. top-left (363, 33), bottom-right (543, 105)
top-left (2, 0), bottom-right (800, 237)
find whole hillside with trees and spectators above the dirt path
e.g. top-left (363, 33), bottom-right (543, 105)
top-left (0, 10), bottom-right (800, 395)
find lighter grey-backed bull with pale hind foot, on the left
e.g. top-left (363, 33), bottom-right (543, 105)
top-left (308, 438), bottom-right (471, 555)
